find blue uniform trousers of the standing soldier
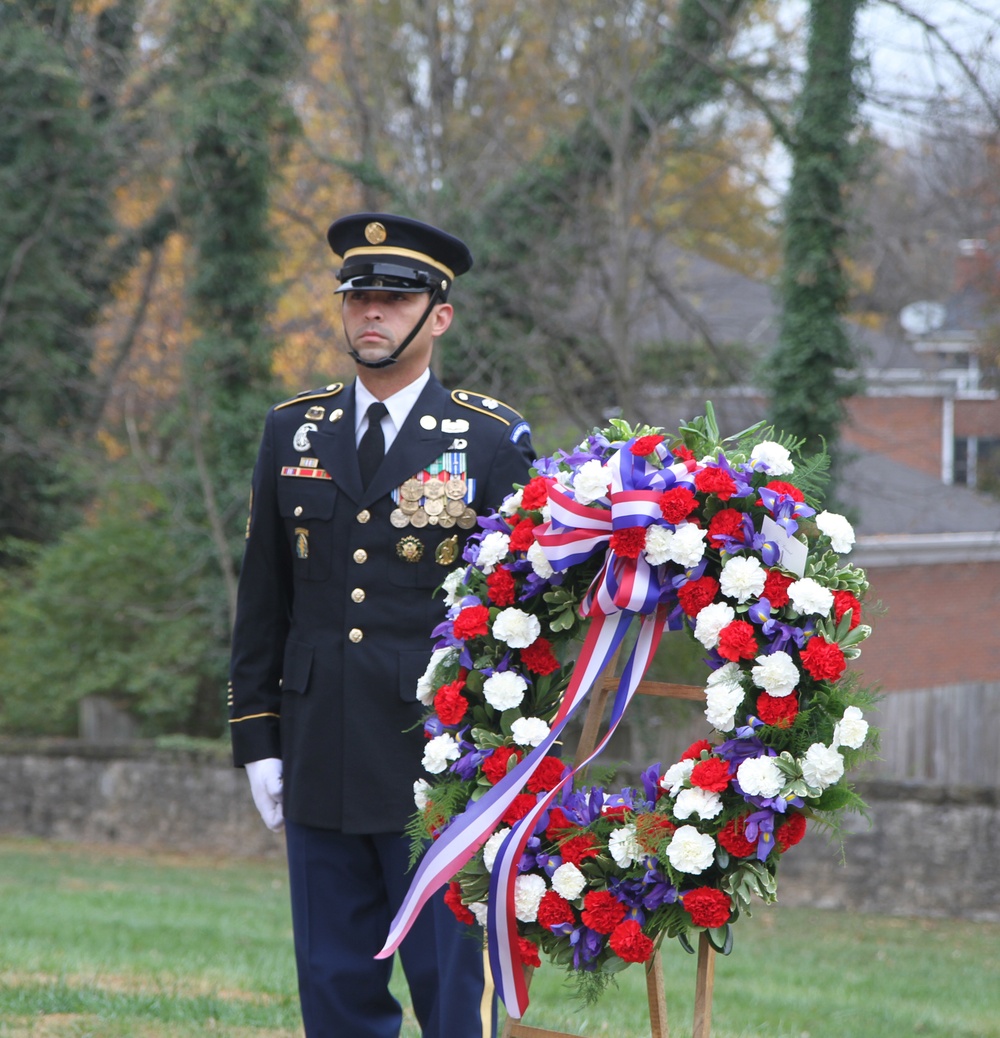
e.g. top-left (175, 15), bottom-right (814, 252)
top-left (286, 822), bottom-right (495, 1038)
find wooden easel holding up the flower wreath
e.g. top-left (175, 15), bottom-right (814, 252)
top-left (501, 659), bottom-right (715, 1038)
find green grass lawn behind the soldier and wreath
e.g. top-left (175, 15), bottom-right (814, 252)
top-left (0, 839), bottom-right (1000, 1038)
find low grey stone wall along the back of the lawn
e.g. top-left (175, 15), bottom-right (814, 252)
top-left (0, 740), bottom-right (1000, 922)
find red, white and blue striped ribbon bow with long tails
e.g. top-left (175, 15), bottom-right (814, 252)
top-left (376, 447), bottom-right (692, 1017)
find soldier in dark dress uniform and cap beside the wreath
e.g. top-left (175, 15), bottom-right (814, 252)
top-left (229, 213), bottom-right (534, 1038)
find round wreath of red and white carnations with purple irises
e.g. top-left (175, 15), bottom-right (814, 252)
top-left (411, 406), bottom-right (875, 1008)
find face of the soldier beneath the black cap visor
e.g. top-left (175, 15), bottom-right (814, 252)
top-left (342, 289), bottom-right (452, 366)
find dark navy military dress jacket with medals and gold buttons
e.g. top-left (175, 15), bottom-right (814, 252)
top-left (229, 375), bottom-right (534, 832)
